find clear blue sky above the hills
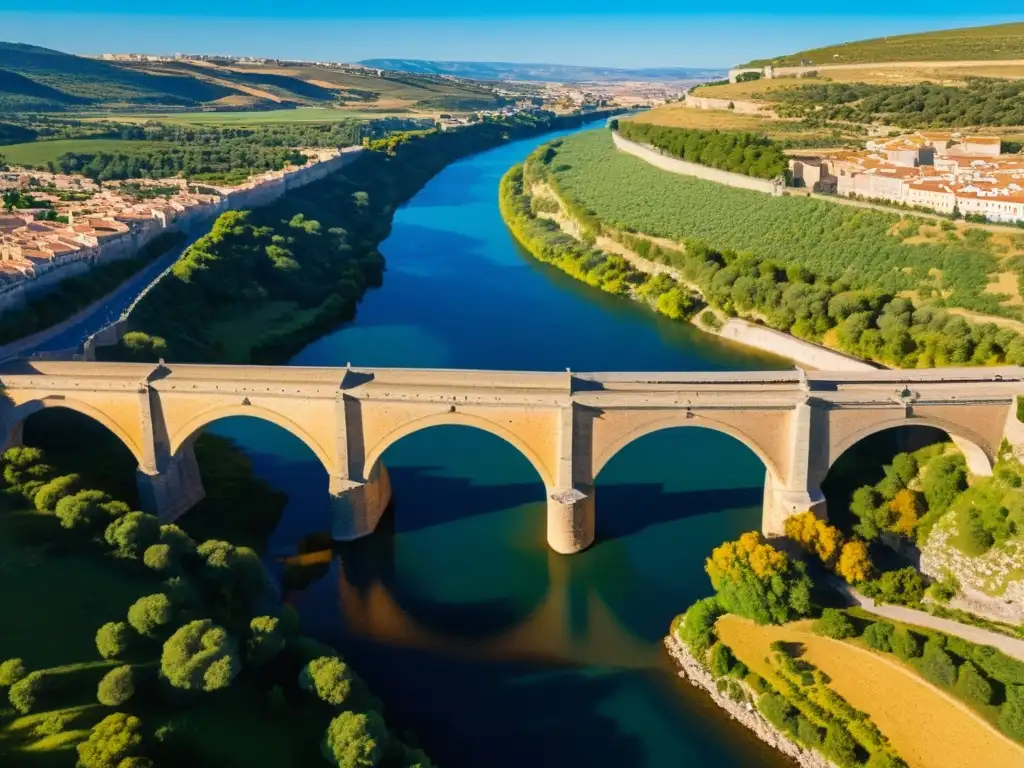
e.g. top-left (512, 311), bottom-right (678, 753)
top-left (0, 0), bottom-right (1024, 67)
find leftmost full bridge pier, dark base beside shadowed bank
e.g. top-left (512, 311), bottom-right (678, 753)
top-left (135, 384), bottom-right (206, 522)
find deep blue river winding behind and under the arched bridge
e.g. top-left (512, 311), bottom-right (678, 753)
top-left (195, 123), bottom-right (790, 768)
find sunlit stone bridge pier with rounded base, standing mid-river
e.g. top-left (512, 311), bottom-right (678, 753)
top-left (546, 402), bottom-right (595, 555)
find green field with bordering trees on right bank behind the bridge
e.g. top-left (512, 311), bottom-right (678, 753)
top-left (502, 129), bottom-right (1024, 368)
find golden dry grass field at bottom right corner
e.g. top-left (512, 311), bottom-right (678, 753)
top-left (718, 615), bottom-right (1024, 768)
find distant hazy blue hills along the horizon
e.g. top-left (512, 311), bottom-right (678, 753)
top-left (359, 58), bottom-right (725, 83)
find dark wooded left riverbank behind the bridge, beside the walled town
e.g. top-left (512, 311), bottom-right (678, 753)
top-left (105, 114), bottom-right (622, 364)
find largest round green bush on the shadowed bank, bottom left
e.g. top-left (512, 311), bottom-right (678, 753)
top-left (160, 618), bottom-right (242, 691)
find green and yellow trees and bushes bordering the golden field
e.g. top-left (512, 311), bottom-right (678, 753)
top-left (672, 528), bottom-right (1024, 768)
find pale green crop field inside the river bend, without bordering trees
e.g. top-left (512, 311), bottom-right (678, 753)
top-left (551, 131), bottom-right (1024, 318)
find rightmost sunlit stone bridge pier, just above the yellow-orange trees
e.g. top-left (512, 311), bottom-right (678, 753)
top-left (761, 399), bottom-right (827, 538)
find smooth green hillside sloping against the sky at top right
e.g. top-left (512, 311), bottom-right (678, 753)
top-left (743, 23), bottom-right (1024, 67)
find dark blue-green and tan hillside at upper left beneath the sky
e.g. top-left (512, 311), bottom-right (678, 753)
top-left (0, 43), bottom-right (502, 114)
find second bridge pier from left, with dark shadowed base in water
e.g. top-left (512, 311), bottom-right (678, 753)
top-left (328, 391), bottom-right (391, 542)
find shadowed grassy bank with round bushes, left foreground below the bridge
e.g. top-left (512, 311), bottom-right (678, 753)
top-left (0, 415), bottom-right (431, 768)
